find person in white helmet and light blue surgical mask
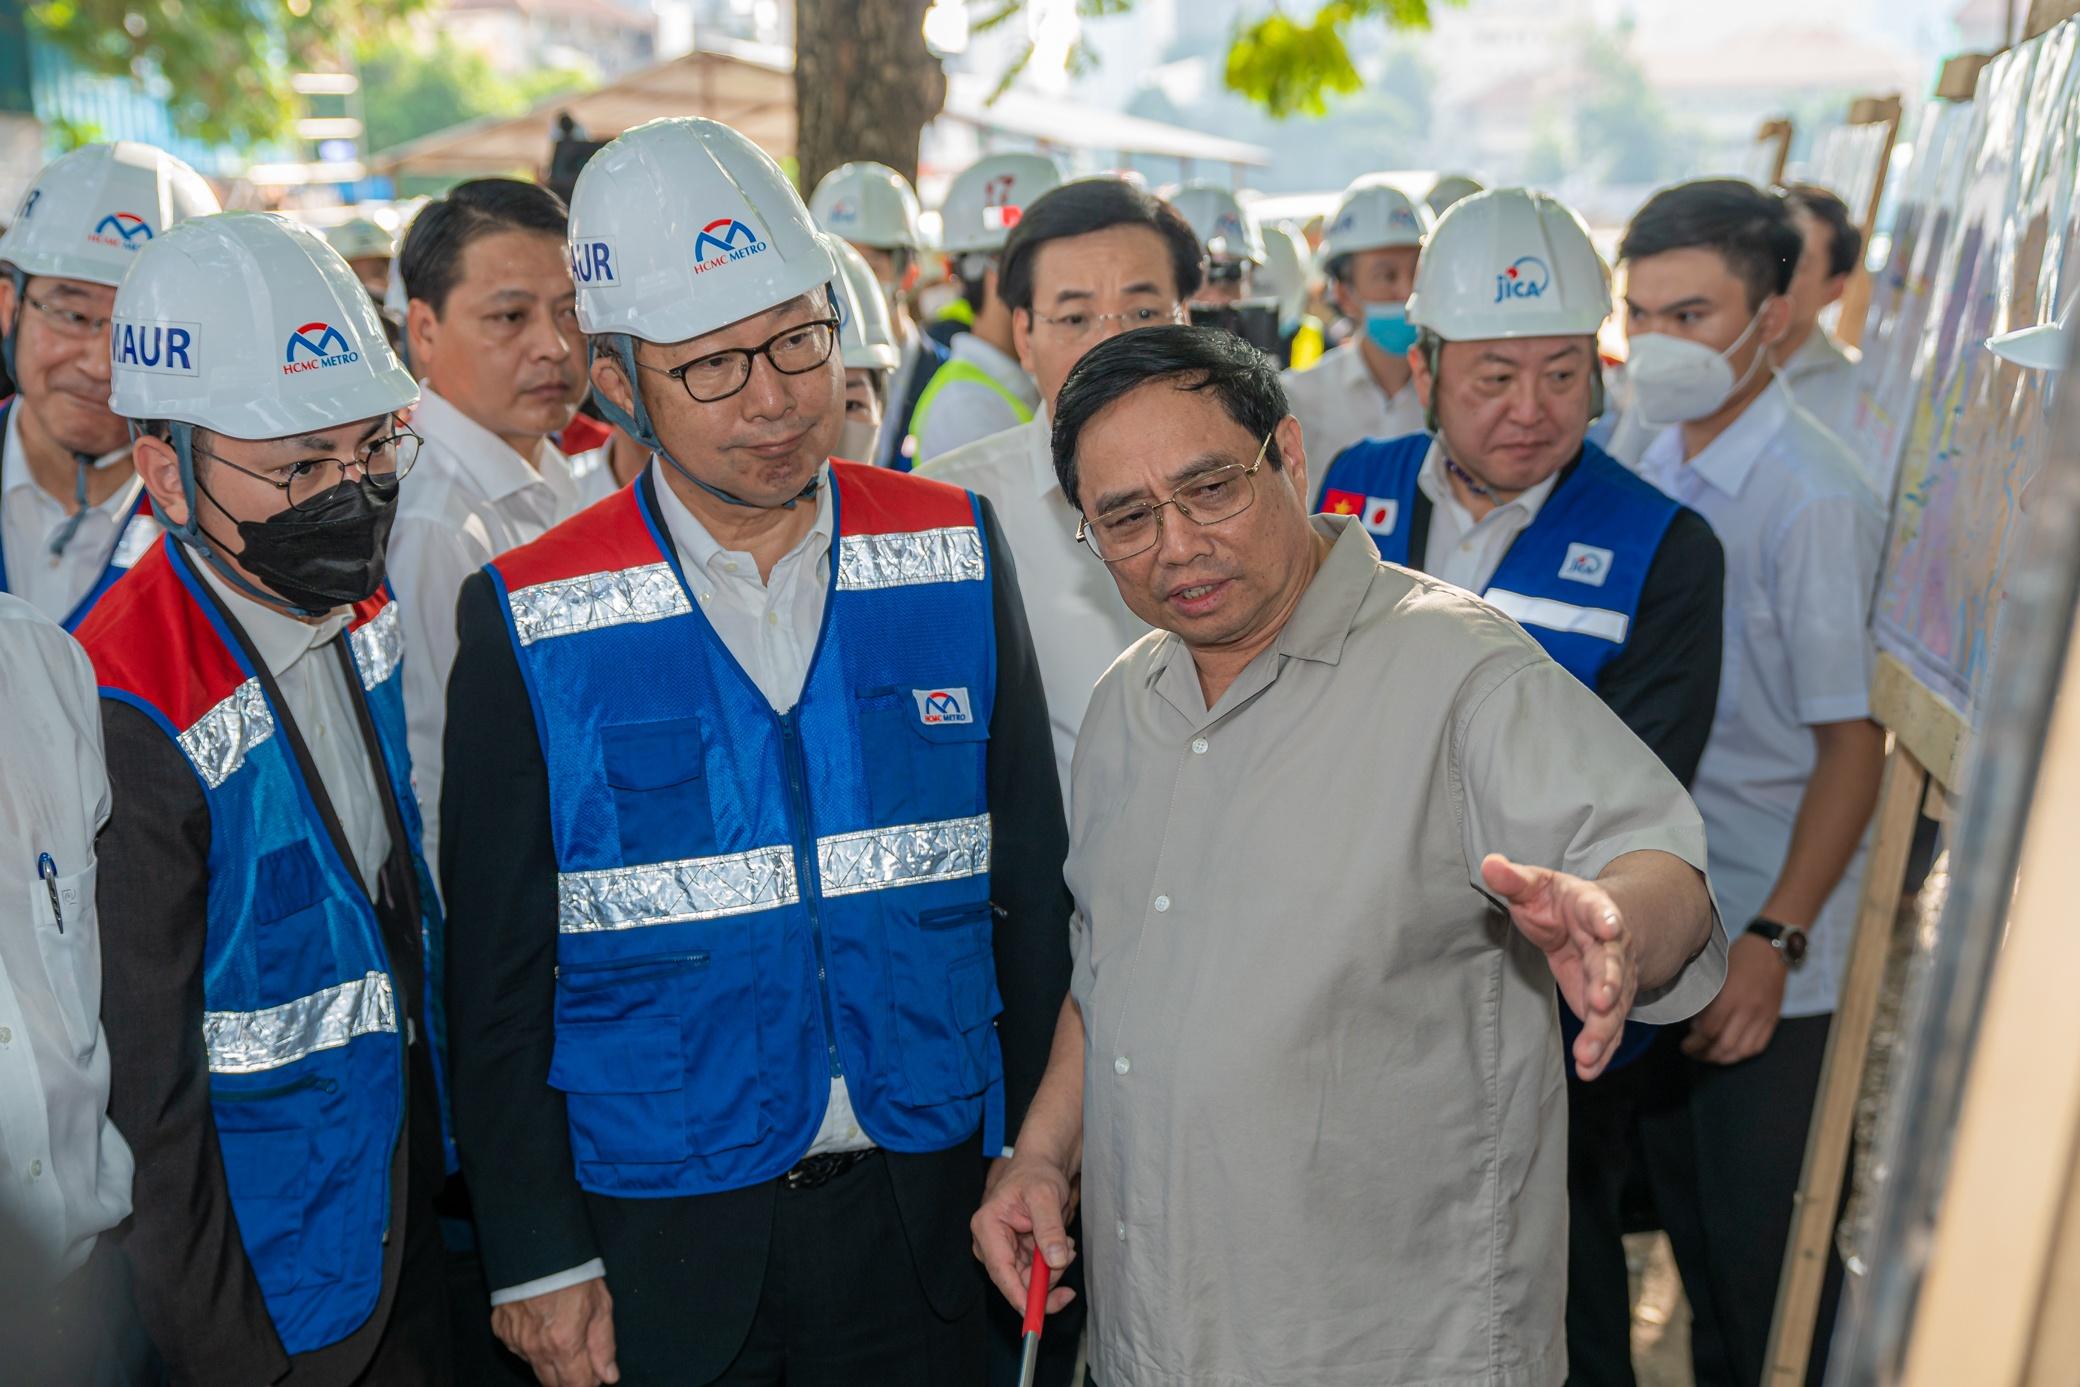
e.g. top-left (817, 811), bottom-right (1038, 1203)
top-left (1281, 175), bottom-right (1435, 501)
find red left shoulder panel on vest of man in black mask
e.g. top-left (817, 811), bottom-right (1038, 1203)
top-left (79, 545), bottom-right (245, 730)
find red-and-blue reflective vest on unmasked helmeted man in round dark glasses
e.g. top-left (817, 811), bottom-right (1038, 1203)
top-left (487, 462), bottom-right (1003, 1198)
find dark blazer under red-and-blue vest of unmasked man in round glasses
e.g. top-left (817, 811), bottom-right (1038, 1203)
top-left (441, 492), bottom-right (1071, 1383)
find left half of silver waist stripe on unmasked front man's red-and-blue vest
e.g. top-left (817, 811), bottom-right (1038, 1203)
top-left (555, 846), bottom-right (801, 934)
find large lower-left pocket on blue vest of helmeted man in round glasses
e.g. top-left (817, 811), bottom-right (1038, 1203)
top-left (549, 952), bottom-right (765, 1164)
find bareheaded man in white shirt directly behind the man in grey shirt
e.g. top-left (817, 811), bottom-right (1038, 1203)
top-left (924, 179), bottom-right (1200, 794)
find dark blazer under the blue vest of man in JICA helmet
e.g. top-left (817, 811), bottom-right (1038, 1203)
top-left (1408, 460), bottom-right (1726, 786)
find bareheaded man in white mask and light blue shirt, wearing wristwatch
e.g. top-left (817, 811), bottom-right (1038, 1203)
top-left (1618, 179), bottom-right (1884, 1383)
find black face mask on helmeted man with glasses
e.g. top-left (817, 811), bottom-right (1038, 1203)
top-left (210, 478), bottom-right (397, 611)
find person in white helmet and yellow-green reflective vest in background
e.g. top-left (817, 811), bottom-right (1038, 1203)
top-left (899, 154), bottom-right (1061, 466)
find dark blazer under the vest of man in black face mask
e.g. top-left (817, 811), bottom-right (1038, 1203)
top-left (96, 595), bottom-right (447, 1387)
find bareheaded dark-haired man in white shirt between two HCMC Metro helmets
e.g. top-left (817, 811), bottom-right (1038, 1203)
top-left (389, 179), bottom-right (587, 877)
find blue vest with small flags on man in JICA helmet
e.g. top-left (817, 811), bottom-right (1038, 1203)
top-left (1321, 433), bottom-right (1681, 1073)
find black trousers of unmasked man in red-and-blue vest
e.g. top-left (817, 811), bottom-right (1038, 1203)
top-left (703, 1152), bottom-right (984, 1387)
